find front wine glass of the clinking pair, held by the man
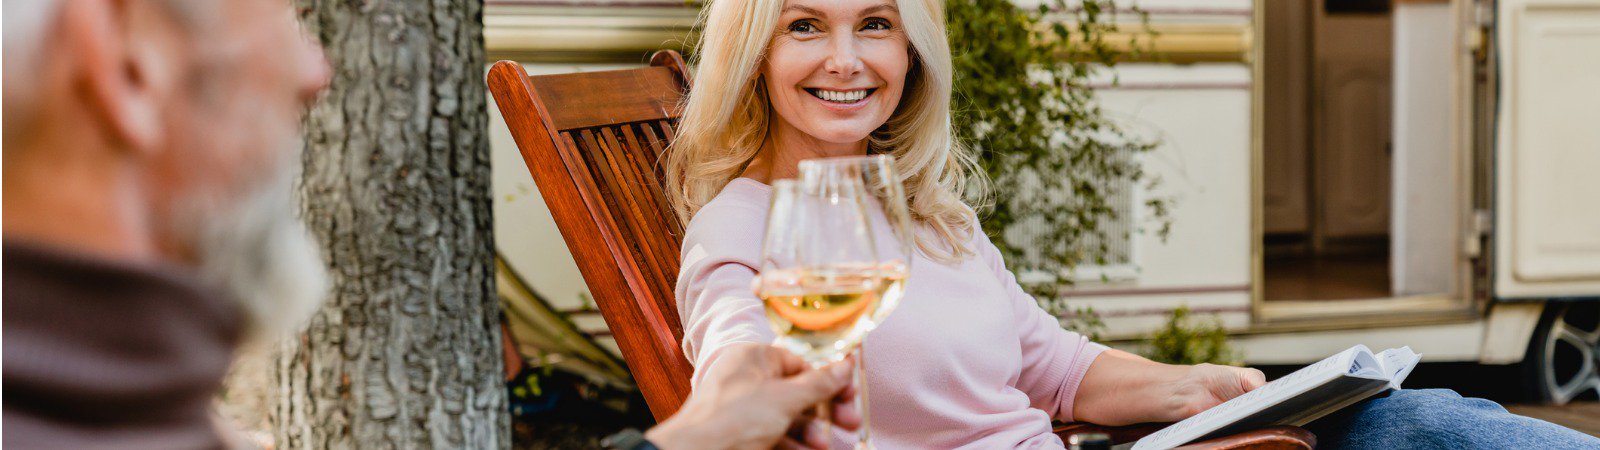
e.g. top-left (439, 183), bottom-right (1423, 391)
top-left (757, 178), bottom-right (883, 445)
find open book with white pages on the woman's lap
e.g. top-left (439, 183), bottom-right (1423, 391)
top-left (1133, 346), bottom-right (1422, 450)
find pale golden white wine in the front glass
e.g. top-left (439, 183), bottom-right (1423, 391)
top-left (760, 267), bottom-right (882, 364)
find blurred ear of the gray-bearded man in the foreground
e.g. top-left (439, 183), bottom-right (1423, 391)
top-left (61, 0), bottom-right (163, 154)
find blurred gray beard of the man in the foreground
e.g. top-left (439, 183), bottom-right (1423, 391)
top-left (186, 160), bottom-right (328, 340)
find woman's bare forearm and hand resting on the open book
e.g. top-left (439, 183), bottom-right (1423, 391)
top-left (1072, 349), bottom-right (1267, 426)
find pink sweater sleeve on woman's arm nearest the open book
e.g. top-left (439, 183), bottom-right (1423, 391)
top-left (973, 231), bottom-right (1106, 421)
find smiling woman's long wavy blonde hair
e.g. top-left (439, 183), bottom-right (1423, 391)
top-left (664, 0), bottom-right (987, 261)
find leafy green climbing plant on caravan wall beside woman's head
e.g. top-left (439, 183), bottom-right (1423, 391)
top-left (946, 0), bottom-right (1171, 304)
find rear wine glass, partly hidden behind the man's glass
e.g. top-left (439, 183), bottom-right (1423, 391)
top-left (800, 155), bottom-right (917, 450)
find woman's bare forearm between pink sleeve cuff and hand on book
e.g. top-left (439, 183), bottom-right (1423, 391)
top-left (1072, 349), bottom-right (1189, 426)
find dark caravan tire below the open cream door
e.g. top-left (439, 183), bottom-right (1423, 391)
top-left (1523, 301), bottom-right (1600, 405)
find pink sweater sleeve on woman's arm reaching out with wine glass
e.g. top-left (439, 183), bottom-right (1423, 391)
top-left (675, 205), bottom-right (776, 386)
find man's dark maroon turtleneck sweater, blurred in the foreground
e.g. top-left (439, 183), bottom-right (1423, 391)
top-left (0, 242), bottom-right (242, 450)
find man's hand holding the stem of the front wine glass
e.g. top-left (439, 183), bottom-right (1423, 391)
top-left (645, 344), bottom-right (861, 450)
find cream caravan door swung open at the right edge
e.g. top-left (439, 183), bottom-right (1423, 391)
top-left (1493, 0), bottom-right (1600, 299)
